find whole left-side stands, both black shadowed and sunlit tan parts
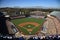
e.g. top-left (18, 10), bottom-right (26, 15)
top-left (0, 12), bottom-right (20, 37)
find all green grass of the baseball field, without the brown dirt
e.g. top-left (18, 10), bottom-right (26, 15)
top-left (12, 18), bottom-right (44, 34)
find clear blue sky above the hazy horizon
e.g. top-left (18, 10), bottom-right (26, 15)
top-left (0, 0), bottom-right (60, 8)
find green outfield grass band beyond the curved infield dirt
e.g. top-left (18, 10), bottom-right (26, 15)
top-left (12, 18), bottom-right (44, 25)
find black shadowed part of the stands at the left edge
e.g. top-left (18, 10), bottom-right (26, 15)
top-left (0, 12), bottom-right (9, 35)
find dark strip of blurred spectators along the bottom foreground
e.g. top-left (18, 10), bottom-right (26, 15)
top-left (0, 34), bottom-right (60, 40)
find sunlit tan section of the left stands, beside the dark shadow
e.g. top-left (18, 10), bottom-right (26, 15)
top-left (5, 15), bottom-right (20, 37)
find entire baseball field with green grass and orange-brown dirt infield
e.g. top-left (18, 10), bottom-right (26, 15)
top-left (12, 18), bottom-right (44, 35)
